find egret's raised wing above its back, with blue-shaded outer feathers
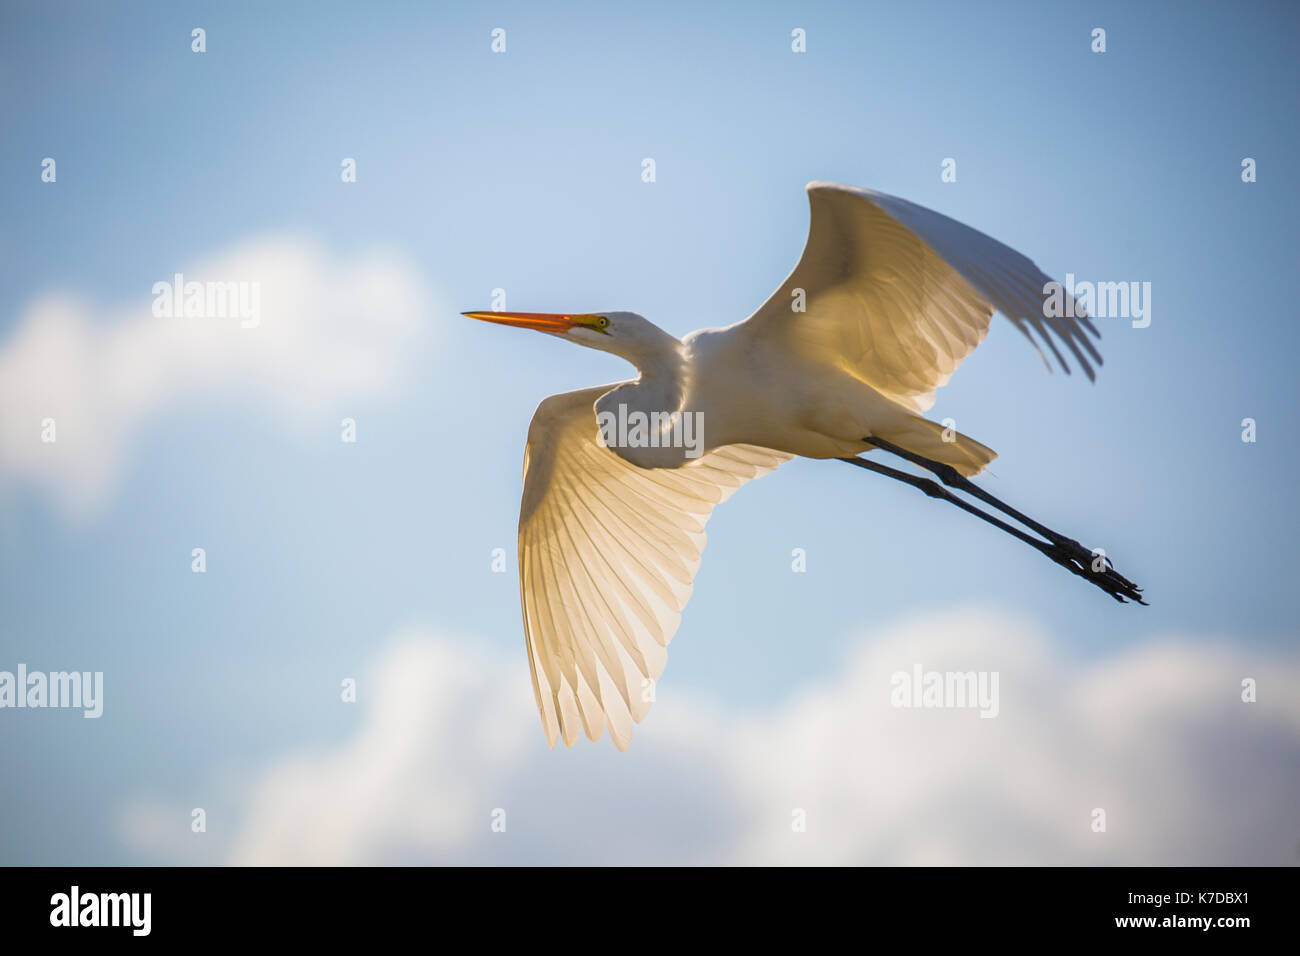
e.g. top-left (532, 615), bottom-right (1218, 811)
top-left (742, 182), bottom-right (1101, 411)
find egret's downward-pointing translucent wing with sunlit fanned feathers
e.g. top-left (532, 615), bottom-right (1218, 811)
top-left (519, 385), bottom-right (790, 749)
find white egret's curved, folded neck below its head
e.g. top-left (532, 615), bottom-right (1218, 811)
top-left (595, 333), bottom-right (703, 468)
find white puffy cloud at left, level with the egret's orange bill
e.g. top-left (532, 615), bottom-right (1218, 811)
top-left (0, 237), bottom-right (432, 514)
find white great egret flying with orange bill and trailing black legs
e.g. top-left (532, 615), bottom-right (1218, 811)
top-left (464, 182), bottom-right (1141, 749)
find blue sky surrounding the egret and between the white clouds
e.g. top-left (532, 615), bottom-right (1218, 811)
top-left (0, 3), bottom-right (1300, 862)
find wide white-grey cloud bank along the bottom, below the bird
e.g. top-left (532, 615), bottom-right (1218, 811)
top-left (126, 609), bottom-right (1300, 865)
